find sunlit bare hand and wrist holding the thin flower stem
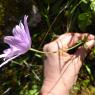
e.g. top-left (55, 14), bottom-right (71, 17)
top-left (40, 33), bottom-right (95, 95)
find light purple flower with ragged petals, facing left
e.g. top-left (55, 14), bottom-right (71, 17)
top-left (0, 15), bottom-right (31, 67)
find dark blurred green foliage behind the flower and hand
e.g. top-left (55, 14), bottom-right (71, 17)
top-left (0, 0), bottom-right (95, 95)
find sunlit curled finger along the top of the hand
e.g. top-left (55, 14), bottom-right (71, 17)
top-left (57, 33), bottom-right (94, 51)
